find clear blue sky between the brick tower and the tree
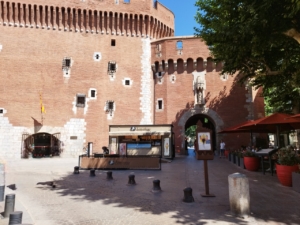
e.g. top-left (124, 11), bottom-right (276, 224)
top-left (158, 0), bottom-right (199, 36)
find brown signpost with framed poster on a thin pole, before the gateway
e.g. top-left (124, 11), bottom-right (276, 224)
top-left (195, 120), bottom-right (215, 197)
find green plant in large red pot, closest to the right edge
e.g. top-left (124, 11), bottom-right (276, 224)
top-left (276, 146), bottom-right (300, 187)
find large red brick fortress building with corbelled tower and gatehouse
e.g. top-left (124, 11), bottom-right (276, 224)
top-left (0, 0), bottom-right (264, 158)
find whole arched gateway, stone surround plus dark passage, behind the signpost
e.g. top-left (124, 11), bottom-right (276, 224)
top-left (175, 106), bottom-right (224, 154)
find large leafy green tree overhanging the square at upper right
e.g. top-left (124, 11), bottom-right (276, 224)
top-left (195, 0), bottom-right (300, 112)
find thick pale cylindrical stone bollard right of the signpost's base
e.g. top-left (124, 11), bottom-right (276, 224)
top-left (228, 173), bottom-right (250, 216)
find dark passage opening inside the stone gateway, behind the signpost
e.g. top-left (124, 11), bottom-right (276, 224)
top-left (185, 114), bottom-right (217, 150)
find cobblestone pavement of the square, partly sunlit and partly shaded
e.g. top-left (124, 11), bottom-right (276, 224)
top-left (0, 149), bottom-right (300, 225)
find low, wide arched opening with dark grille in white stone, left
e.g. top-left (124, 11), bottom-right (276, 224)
top-left (22, 132), bottom-right (61, 158)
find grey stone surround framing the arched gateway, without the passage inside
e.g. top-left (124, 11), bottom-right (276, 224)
top-left (177, 106), bottom-right (224, 154)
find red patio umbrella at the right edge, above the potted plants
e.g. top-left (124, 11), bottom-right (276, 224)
top-left (239, 113), bottom-right (300, 147)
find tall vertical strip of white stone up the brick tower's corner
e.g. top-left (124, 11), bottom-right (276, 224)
top-left (140, 38), bottom-right (153, 125)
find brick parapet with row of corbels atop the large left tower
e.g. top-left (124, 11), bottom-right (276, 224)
top-left (0, 0), bottom-right (174, 39)
